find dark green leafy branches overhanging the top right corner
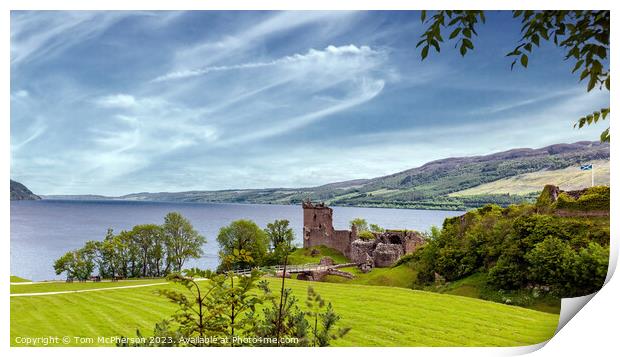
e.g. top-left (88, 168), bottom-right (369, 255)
top-left (416, 10), bottom-right (610, 142)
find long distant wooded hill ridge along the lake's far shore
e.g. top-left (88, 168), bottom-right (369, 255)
top-left (46, 141), bottom-right (609, 209)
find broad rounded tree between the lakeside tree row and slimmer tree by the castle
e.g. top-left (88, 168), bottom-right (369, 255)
top-left (217, 219), bottom-right (269, 270)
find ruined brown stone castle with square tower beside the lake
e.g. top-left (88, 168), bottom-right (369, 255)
top-left (302, 201), bottom-right (424, 267)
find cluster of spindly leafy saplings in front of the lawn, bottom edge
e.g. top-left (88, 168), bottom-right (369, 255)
top-left (117, 268), bottom-right (350, 347)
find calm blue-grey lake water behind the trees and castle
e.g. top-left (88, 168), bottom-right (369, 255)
top-left (11, 200), bottom-right (463, 280)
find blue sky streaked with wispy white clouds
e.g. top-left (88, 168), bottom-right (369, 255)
top-left (10, 11), bottom-right (610, 195)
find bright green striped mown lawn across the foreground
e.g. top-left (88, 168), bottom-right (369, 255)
top-left (11, 278), bottom-right (558, 346)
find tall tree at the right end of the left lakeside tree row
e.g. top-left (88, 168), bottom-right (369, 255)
top-left (163, 212), bottom-right (207, 271)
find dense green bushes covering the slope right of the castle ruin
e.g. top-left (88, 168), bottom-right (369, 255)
top-left (412, 187), bottom-right (610, 301)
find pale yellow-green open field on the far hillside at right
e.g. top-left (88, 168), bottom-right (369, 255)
top-left (449, 160), bottom-right (610, 197)
